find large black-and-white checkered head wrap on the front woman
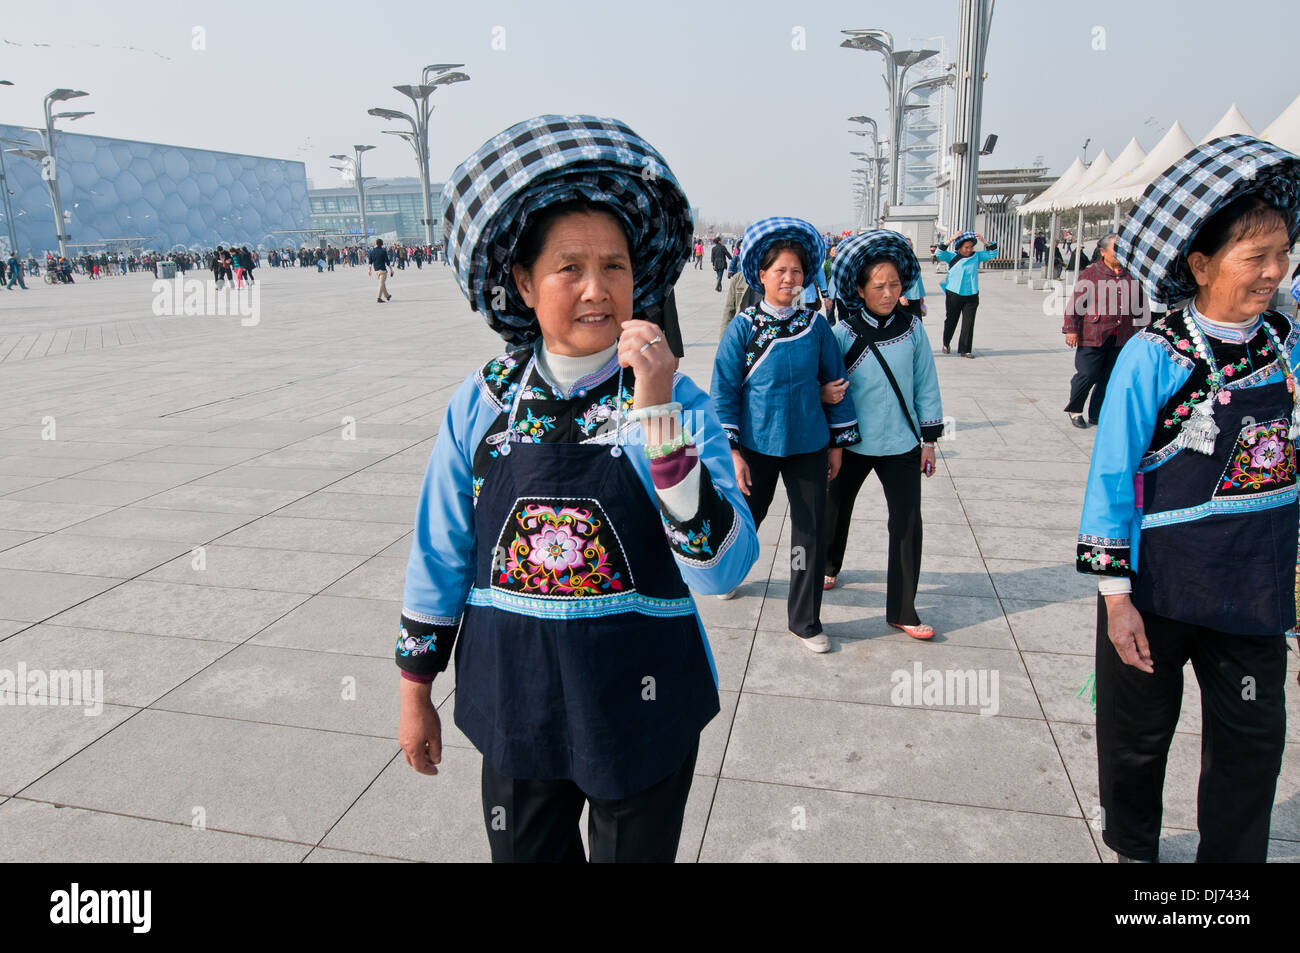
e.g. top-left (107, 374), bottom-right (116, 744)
top-left (442, 116), bottom-right (692, 345)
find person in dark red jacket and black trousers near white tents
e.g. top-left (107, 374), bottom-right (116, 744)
top-left (1061, 233), bottom-right (1145, 429)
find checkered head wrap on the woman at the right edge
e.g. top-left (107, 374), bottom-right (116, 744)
top-left (1115, 135), bottom-right (1300, 304)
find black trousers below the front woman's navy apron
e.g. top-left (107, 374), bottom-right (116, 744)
top-left (482, 741), bottom-right (699, 863)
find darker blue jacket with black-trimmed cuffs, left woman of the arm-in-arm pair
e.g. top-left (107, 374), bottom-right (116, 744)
top-left (711, 306), bottom-right (861, 456)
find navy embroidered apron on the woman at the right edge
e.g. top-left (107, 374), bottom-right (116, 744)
top-left (1132, 372), bottom-right (1300, 634)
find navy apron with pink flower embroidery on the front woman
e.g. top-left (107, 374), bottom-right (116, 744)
top-left (455, 382), bottom-right (719, 798)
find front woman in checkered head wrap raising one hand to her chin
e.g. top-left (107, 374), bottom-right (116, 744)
top-left (397, 116), bottom-right (758, 862)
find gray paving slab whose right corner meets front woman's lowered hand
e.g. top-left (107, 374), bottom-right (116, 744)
top-left (21, 710), bottom-right (398, 844)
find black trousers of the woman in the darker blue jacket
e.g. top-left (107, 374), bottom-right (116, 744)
top-left (740, 447), bottom-right (826, 638)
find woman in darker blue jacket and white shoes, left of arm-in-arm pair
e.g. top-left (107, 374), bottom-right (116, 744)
top-left (711, 217), bottom-right (858, 653)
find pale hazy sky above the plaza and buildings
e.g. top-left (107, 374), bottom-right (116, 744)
top-left (0, 0), bottom-right (1300, 228)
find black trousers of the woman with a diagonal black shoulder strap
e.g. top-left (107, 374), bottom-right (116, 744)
top-left (826, 446), bottom-right (922, 625)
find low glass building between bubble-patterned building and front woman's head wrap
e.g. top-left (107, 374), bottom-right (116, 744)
top-left (308, 176), bottom-right (442, 244)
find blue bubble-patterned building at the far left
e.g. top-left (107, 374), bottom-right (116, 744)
top-left (0, 125), bottom-right (311, 257)
